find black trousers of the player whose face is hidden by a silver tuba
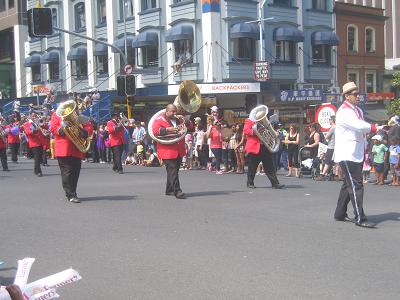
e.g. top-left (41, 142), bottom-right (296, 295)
top-left (247, 144), bottom-right (279, 186)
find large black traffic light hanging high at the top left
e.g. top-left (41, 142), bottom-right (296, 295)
top-left (27, 7), bottom-right (53, 38)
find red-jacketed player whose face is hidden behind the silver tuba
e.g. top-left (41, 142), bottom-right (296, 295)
top-left (243, 103), bottom-right (285, 189)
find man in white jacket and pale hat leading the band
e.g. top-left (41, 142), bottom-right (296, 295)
top-left (334, 82), bottom-right (377, 228)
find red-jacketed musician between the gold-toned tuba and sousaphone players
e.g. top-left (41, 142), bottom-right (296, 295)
top-left (106, 113), bottom-right (125, 174)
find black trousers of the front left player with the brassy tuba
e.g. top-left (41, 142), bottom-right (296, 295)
top-left (57, 156), bottom-right (82, 199)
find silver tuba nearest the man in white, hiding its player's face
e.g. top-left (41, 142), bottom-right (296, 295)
top-left (249, 105), bottom-right (281, 153)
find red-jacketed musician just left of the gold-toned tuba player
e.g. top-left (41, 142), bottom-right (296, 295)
top-left (24, 112), bottom-right (43, 177)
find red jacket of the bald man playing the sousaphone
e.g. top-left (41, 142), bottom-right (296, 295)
top-left (151, 113), bottom-right (186, 159)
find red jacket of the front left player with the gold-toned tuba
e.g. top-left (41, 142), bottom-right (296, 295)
top-left (50, 113), bottom-right (93, 159)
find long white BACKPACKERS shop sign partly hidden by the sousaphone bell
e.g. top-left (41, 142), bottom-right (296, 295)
top-left (168, 82), bottom-right (260, 95)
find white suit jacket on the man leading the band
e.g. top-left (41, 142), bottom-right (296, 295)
top-left (335, 101), bottom-right (376, 162)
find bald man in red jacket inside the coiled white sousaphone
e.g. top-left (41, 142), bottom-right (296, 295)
top-left (152, 104), bottom-right (186, 199)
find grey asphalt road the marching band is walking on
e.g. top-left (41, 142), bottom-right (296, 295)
top-left (0, 159), bottom-right (400, 300)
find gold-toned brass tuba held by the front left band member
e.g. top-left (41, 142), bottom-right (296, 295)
top-left (56, 100), bottom-right (90, 153)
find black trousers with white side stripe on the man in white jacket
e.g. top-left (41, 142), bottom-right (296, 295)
top-left (335, 161), bottom-right (367, 222)
